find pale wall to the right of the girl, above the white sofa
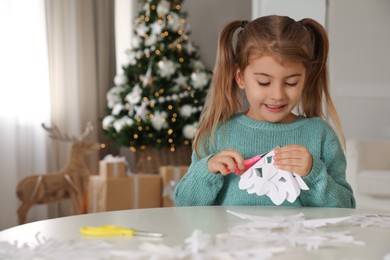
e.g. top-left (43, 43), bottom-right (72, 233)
top-left (328, 0), bottom-right (390, 138)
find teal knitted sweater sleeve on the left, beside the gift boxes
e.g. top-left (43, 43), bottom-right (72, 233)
top-left (174, 152), bottom-right (224, 206)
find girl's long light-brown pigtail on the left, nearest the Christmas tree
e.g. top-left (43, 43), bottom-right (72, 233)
top-left (193, 21), bottom-right (241, 156)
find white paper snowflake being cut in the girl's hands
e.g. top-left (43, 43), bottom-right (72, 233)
top-left (238, 149), bottom-right (309, 205)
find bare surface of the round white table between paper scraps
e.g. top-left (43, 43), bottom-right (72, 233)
top-left (0, 206), bottom-right (390, 260)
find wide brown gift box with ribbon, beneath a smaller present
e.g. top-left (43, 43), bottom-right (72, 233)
top-left (87, 174), bottom-right (161, 213)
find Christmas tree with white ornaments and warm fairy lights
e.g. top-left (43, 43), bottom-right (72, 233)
top-left (102, 0), bottom-right (211, 152)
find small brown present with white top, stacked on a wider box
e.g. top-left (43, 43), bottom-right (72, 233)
top-left (99, 154), bottom-right (127, 178)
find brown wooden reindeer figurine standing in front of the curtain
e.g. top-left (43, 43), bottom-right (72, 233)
top-left (16, 123), bottom-right (100, 224)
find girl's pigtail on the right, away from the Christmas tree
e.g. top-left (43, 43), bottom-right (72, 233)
top-left (300, 18), bottom-right (345, 147)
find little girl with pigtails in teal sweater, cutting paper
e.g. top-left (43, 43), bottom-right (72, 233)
top-left (174, 15), bottom-right (355, 208)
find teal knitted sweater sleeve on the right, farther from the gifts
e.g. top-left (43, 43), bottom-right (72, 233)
top-left (300, 133), bottom-right (356, 208)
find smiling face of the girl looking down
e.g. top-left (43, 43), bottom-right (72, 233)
top-left (236, 56), bottom-right (306, 123)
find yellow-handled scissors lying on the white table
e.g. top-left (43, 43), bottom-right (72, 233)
top-left (80, 225), bottom-right (164, 238)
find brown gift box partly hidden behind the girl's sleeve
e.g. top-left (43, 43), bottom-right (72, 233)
top-left (159, 166), bottom-right (189, 207)
